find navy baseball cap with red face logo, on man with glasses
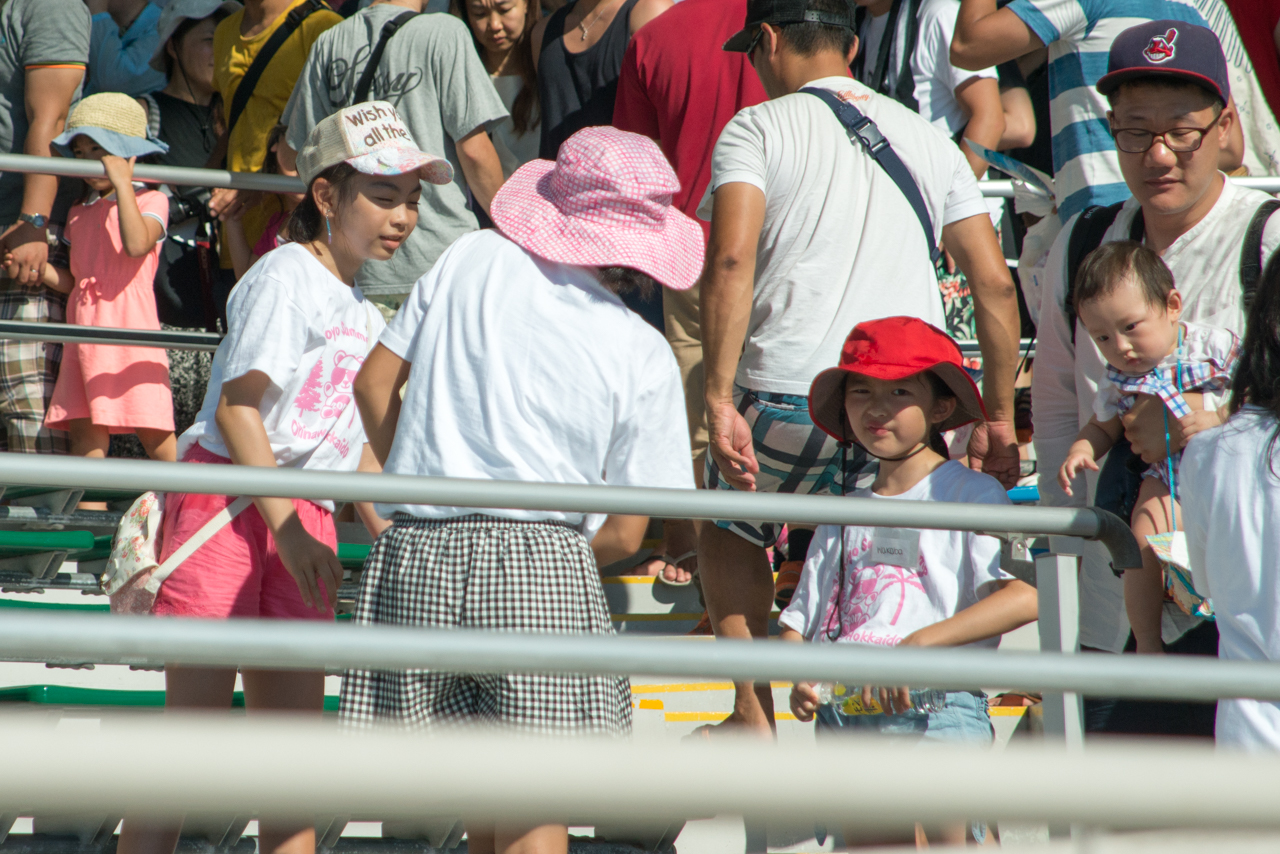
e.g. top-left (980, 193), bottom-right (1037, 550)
top-left (1097, 20), bottom-right (1231, 104)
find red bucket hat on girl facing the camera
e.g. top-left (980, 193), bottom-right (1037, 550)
top-left (809, 318), bottom-right (987, 442)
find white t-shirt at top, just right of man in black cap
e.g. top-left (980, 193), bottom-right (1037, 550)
top-left (911, 0), bottom-right (997, 137)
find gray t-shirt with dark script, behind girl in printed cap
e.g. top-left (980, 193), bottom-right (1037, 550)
top-left (280, 4), bottom-right (507, 296)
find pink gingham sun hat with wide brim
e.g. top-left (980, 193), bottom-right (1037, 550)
top-left (489, 127), bottom-right (705, 291)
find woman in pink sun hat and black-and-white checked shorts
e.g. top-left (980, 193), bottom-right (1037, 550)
top-left (340, 128), bottom-right (703, 854)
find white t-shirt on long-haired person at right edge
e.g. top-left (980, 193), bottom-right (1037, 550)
top-left (1181, 407), bottom-right (1280, 752)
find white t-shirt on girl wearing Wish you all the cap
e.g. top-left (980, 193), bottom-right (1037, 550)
top-left (178, 243), bottom-right (387, 510)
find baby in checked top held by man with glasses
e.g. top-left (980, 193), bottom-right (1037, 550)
top-left (1057, 241), bottom-right (1239, 653)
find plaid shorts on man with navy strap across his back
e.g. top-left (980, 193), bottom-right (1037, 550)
top-left (704, 387), bottom-right (867, 548)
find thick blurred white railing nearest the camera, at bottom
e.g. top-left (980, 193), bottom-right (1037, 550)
top-left (0, 714), bottom-right (1280, 829)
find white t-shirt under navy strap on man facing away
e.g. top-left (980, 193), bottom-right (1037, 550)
top-left (698, 77), bottom-right (987, 394)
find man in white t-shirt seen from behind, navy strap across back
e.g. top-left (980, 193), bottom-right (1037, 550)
top-left (699, 0), bottom-right (1019, 732)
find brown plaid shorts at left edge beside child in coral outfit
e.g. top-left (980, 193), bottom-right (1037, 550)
top-left (0, 277), bottom-right (70, 453)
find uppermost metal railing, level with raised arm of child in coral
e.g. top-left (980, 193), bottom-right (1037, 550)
top-left (0, 154), bottom-right (1280, 198)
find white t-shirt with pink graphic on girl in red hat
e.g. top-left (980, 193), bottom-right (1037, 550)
top-left (778, 461), bottom-right (1014, 648)
